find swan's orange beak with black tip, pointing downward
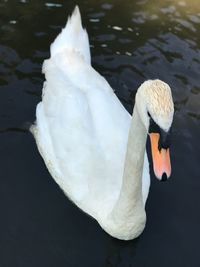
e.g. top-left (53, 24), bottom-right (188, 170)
top-left (149, 133), bottom-right (171, 181)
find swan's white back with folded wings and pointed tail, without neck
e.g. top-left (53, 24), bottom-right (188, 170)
top-left (32, 7), bottom-right (130, 221)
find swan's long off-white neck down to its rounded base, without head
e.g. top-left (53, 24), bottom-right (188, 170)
top-left (103, 105), bottom-right (147, 239)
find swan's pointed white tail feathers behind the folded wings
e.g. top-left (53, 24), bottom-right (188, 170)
top-left (51, 6), bottom-right (91, 64)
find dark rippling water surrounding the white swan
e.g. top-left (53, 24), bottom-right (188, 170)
top-left (0, 0), bottom-right (200, 267)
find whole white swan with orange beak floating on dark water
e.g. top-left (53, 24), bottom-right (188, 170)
top-left (31, 6), bottom-right (174, 240)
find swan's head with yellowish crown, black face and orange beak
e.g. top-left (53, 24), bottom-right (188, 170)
top-left (136, 80), bottom-right (174, 181)
